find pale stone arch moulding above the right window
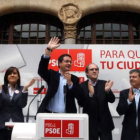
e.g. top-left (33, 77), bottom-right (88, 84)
top-left (80, 0), bottom-right (140, 17)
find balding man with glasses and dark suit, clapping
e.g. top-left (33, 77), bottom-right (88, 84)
top-left (81, 63), bottom-right (115, 140)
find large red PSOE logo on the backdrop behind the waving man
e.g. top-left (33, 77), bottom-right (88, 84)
top-left (48, 49), bottom-right (92, 72)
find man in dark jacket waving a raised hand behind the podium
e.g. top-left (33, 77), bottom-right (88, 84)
top-left (38, 37), bottom-right (83, 113)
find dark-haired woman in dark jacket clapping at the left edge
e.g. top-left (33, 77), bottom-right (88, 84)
top-left (0, 67), bottom-right (35, 140)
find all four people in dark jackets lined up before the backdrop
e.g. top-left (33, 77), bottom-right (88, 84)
top-left (0, 37), bottom-right (140, 140)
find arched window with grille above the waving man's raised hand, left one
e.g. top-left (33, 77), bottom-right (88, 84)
top-left (0, 13), bottom-right (64, 44)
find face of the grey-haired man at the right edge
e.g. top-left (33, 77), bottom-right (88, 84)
top-left (129, 72), bottom-right (140, 88)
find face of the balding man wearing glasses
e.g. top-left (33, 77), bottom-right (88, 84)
top-left (86, 64), bottom-right (99, 81)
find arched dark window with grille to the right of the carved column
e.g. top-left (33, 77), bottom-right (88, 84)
top-left (77, 12), bottom-right (140, 44)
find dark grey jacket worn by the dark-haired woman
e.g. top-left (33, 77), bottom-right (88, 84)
top-left (0, 87), bottom-right (28, 129)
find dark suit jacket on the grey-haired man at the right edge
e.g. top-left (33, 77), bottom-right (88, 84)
top-left (117, 89), bottom-right (140, 140)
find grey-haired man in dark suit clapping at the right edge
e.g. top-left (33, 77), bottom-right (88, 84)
top-left (117, 69), bottom-right (140, 140)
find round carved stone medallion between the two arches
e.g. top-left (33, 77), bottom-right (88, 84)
top-left (58, 3), bottom-right (82, 24)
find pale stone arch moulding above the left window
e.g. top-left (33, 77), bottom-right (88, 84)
top-left (0, 0), bottom-right (58, 17)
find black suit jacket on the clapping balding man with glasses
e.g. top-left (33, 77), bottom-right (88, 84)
top-left (81, 80), bottom-right (115, 137)
